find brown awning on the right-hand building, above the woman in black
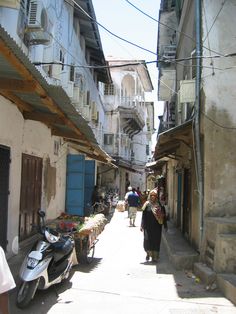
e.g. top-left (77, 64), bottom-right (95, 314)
top-left (153, 120), bottom-right (193, 160)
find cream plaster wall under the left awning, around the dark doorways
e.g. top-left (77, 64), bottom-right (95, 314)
top-left (0, 96), bottom-right (66, 252)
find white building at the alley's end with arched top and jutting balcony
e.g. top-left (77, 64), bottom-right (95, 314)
top-left (98, 58), bottom-right (154, 198)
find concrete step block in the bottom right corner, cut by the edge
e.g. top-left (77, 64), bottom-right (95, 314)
top-left (217, 274), bottom-right (236, 305)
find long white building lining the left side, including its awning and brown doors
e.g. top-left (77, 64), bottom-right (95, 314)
top-left (0, 0), bottom-right (111, 255)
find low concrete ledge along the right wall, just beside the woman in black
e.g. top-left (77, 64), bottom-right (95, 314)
top-left (162, 222), bottom-right (199, 270)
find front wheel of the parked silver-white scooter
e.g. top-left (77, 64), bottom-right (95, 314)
top-left (16, 279), bottom-right (38, 309)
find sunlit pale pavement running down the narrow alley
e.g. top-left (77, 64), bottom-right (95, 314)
top-left (10, 211), bottom-right (236, 314)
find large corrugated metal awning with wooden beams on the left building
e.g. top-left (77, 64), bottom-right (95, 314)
top-left (0, 25), bottom-right (113, 163)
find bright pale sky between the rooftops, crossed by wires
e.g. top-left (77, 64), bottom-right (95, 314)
top-left (93, 0), bottom-right (163, 145)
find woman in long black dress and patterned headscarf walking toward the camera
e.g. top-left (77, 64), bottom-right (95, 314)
top-left (140, 190), bottom-right (167, 263)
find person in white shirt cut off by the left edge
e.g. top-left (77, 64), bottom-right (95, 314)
top-left (0, 246), bottom-right (16, 314)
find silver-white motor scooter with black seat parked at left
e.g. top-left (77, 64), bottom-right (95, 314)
top-left (16, 211), bottom-right (76, 308)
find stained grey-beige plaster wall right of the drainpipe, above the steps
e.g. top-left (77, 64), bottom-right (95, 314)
top-left (201, 0), bottom-right (236, 216)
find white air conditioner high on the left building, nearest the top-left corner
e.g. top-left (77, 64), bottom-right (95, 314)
top-left (26, 0), bottom-right (51, 45)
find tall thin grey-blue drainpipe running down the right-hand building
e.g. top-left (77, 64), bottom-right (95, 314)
top-left (194, 0), bottom-right (204, 248)
